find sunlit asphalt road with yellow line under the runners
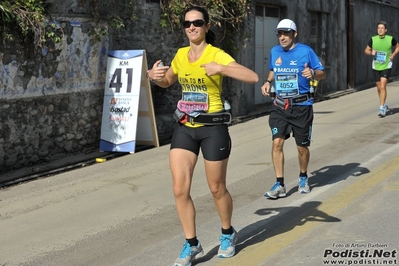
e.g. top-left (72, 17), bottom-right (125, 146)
top-left (0, 82), bottom-right (399, 266)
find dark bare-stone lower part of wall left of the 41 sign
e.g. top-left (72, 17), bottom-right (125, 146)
top-left (0, 90), bottom-right (103, 169)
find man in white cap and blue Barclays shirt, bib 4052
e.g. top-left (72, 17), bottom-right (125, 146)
top-left (261, 19), bottom-right (326, 199)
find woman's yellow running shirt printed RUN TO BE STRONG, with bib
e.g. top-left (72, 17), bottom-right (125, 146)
top-left (172, 44), bottom-right (235, 127)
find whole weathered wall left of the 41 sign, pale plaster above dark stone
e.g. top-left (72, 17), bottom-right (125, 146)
top-left (0, 11), bottom-right (109, 173)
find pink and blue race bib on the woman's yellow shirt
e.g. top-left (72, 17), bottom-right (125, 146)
top-left (177, 92), bottom-right (208, 114)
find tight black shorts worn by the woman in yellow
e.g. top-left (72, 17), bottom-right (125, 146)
top-left (170, 122), bottom-right (231, 161)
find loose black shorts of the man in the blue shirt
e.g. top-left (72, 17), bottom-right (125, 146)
top-left (269, 105), bottom-right (313, 147)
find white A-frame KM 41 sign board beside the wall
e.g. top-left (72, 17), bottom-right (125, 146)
top-left (100, 50), bottom-right (159, 153)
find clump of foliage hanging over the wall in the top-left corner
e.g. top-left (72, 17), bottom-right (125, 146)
top-left (0, 0), bottom-right (61, 47)
